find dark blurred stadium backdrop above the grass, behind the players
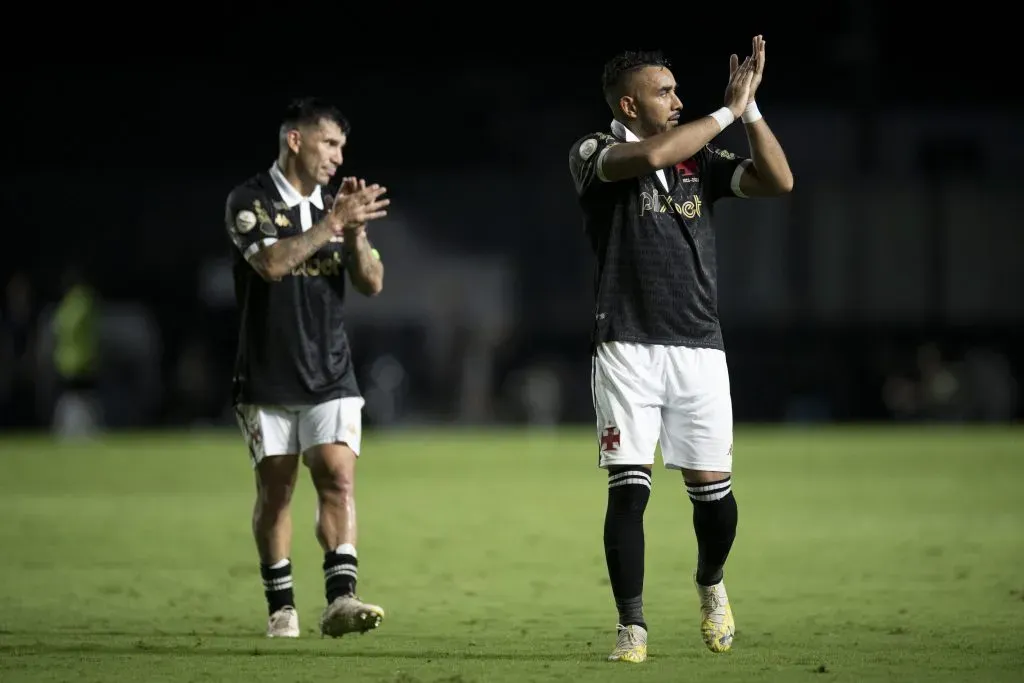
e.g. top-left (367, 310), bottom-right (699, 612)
top-left (0, 2), bottom-right (1024, 428)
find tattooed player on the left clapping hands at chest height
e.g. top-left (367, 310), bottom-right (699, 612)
top-left (224, 98), bottom-right (389, 638)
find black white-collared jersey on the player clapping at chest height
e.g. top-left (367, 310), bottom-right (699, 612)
top-left (224, 171), bottom-right (359, 404)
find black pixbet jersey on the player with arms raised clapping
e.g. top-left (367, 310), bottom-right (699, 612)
top-left (569, 124), bottom-right (744, 349)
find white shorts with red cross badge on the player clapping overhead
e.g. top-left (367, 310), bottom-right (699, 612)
top-left (591, 342), bottom-right (732, 472)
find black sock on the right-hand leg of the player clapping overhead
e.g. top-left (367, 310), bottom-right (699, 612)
top-left (686, 477), bottom-right (738, 586)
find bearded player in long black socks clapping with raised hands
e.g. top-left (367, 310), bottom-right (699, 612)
top-left (569, 36), bottom-right (793, 663)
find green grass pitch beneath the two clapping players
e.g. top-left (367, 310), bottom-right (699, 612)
top-left (0, 427), bottom-right (1024, 683)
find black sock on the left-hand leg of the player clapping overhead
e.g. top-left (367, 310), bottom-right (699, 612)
top-left (604, 466), bottom-right (650, 629)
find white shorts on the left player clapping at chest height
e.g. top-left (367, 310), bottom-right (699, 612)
top-left (234, 396), bottom-right (365, 467)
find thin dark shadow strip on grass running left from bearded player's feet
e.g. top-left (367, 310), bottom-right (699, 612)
top-left (0, 633), bottom-right (594, 661)
